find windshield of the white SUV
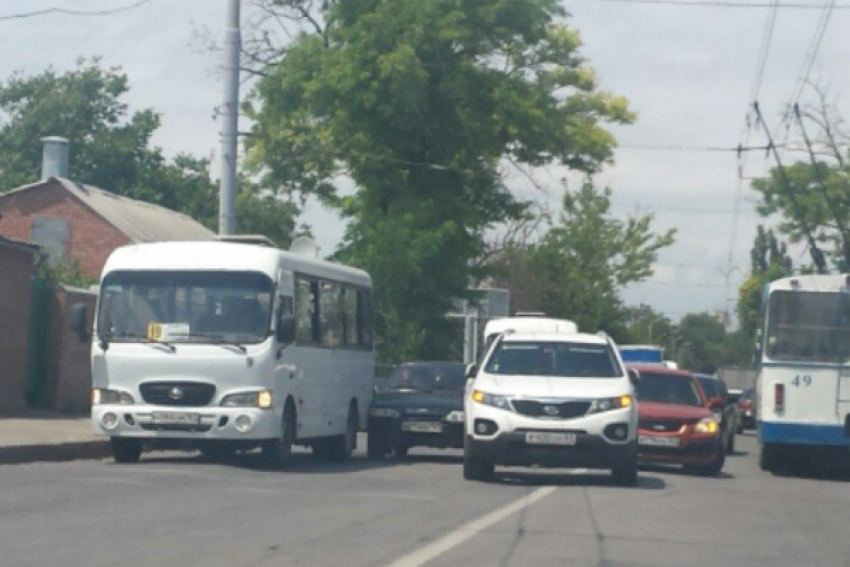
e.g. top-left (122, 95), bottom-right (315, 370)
top-left (485, 341), bottom-right (623, 378)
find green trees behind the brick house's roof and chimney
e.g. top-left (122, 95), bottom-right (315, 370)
top-left (0, 59), bottom-right (298, 246)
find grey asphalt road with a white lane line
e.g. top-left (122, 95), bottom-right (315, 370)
top-left (0, 435), bottom-right (850, 567)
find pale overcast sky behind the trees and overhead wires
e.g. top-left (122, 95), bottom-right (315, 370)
top-left (0, 0), bottom-right (850, 320)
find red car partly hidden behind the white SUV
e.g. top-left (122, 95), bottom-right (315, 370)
top-left (630, 365), bottom-right (726, 476)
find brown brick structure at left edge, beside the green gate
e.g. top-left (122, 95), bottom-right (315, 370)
top-left (0, 237), bottom-right (40, 412)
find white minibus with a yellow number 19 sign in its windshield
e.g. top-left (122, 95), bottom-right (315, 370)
top-left (73, 237), bottom-right (375, 466)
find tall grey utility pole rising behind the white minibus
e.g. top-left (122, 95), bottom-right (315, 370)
top-left (218, 0), bottom-right (242, 235)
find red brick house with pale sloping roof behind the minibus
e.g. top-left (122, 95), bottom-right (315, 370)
top-left (0, 177), bottom-right (215, 279)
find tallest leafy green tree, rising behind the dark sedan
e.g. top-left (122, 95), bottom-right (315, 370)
top-left (247, 0), bottom-right (632, 359)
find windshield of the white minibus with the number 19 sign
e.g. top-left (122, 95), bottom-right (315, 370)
top-left (97, 271), bottom-right (272, 343)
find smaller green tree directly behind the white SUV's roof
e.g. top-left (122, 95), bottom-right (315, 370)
top-left (486, 181), bottom-right (675, 341)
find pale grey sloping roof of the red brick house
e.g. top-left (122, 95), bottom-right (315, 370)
top-left (0, 177), bottom-right (215, 243)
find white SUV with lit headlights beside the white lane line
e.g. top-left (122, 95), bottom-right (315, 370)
top-left (463, 333), bottom-right (639, 485)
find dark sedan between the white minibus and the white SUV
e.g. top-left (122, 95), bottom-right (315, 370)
top-left (368, 362), bottom-right (466, 459)
